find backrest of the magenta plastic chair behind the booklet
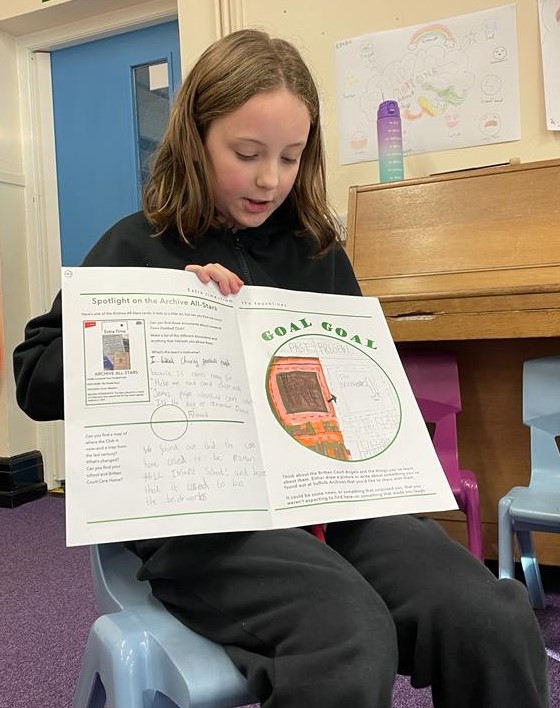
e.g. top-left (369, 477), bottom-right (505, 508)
top-left (398, 347), bottom-right (461, 491)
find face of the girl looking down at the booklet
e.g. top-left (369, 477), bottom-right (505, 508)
top-left (205, 89), bottom-right (310, 228)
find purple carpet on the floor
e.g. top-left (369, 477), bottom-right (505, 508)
top-left (0, 496), bottom-right (560, 708)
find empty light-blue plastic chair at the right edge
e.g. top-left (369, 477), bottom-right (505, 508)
top-left (498, 356), bottom-right (560, 609)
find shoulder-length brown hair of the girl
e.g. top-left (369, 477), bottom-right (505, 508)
top-left (144, 30), bottom-right (339, 253)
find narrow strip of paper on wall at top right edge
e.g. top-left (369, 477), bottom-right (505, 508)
top-left (539, 0), bottom-right (560, 130)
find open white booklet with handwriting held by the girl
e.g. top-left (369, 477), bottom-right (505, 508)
top-left (62, 268), bottom-right (457, 545)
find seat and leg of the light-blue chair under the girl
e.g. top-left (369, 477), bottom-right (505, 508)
top-left (73, 607), bottom-right (255, 708)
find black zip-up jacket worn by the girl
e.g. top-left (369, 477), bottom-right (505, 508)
top-left (14, 206), bottom-right (361, 420)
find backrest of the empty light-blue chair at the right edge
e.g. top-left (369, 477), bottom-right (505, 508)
top-left (523, 356), bottom-right (560, 491)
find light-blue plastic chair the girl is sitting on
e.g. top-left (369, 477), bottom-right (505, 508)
top-left (73, 543), bottom-right (255, 708)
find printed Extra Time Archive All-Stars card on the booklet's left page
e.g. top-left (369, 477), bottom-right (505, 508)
top-left (83, 319), bottom-right (150, 405)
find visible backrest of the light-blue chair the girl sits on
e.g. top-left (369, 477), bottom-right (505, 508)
top-left (90, 543), bottom-right (151, 614)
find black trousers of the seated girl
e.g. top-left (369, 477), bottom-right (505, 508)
top-left (132, 516), bottom-right (549, 708)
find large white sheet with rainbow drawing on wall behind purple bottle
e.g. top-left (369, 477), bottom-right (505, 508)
top-left (335, 0), bottom-right (520, 164)
